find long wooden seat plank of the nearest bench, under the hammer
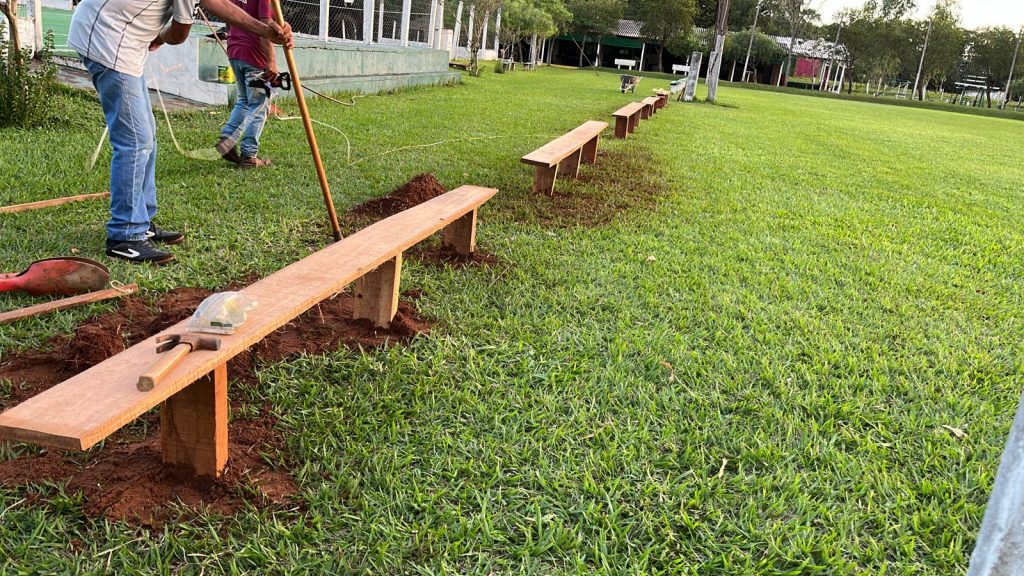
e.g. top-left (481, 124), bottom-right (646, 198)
top-left (0, 186), bottom-right (498, 450)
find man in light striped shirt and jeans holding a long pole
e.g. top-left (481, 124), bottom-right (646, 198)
top-left (68, 0), bottom-right (292, 264)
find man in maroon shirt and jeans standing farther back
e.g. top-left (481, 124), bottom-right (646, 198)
top-left (217, 0), bottom-right (278, 168)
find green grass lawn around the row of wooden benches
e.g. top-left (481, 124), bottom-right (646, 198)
top-left (0, 70), bottom-right (1024, 575)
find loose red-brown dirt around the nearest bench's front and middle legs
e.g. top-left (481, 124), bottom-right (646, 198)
top-left (0, 288), bottom-right (431, 526)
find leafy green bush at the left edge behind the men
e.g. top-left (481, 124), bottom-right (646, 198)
top-left (0, 33), bottom-right (63, 128)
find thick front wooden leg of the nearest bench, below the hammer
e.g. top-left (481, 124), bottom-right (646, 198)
top-left (160, 364), bottom-right (227, 478)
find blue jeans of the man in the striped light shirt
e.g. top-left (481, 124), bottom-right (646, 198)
top-left (82, 56), bottom-right (157, 241)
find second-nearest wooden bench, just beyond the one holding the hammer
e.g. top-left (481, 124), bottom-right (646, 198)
top-left (521, 120), bottom-right (608, 194)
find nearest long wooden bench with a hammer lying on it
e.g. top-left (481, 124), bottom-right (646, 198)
top-left (0, 186), bottom-right (497, 477)
